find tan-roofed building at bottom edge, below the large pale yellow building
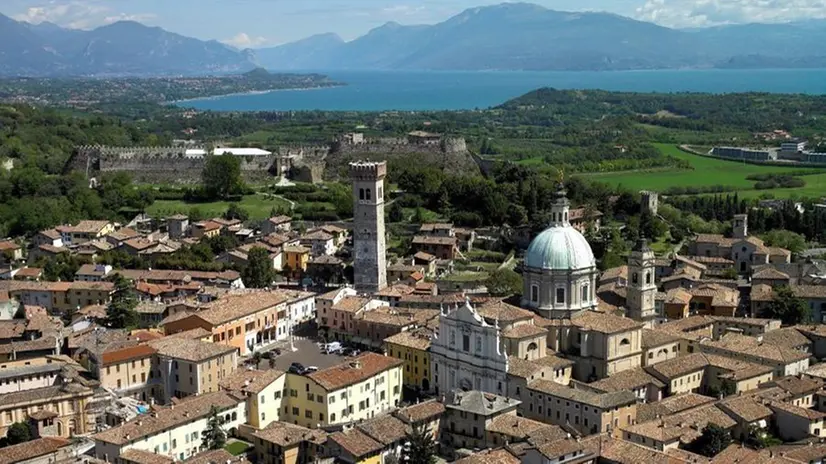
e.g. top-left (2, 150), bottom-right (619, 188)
top-left (252, 422), bottom-right (327, 464)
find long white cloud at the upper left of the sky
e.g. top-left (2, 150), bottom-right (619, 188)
top-left (14, 0), bottom-right (156, 29)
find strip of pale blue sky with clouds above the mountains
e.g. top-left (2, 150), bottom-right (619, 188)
top-left (6, 0), bottom-right (826, 48)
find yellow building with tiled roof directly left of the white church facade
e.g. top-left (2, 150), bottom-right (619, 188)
top-left (384, 329), bottom-right (432, 391)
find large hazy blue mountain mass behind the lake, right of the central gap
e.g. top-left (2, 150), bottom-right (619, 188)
top-left (256, 3), bottom-right (826, 70)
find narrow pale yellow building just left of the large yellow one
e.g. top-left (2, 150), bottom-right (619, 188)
top-left (219, 369), bottom-right (287, 429)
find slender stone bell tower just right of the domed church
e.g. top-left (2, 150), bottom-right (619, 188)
top-left (625, 238), bottom-right (657, 323)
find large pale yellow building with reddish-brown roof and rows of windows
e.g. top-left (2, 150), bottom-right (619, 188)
top-left (281, 353), bottom-right (403, 428)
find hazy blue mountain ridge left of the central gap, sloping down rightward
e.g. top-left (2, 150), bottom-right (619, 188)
top-left (0, 15), bottom-right (256, 76)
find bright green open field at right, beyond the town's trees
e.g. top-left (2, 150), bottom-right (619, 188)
top-left (587, 144), bottom-right (826, 198)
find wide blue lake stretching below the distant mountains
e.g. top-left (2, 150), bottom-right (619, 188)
top-left (180, 69), bottom-right (826, 111)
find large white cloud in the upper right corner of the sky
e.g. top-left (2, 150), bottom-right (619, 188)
top-left (635, 0), bottom-right (826, 27)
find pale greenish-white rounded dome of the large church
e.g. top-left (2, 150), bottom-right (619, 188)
top-left (525, 225), bottom-right (596, 271)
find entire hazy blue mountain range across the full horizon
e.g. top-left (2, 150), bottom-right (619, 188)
top-left (0, 3), bottom-right (826, 75)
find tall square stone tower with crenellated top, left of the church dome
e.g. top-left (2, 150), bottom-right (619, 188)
top-left (350, 161), bottom-right (387, 293)
